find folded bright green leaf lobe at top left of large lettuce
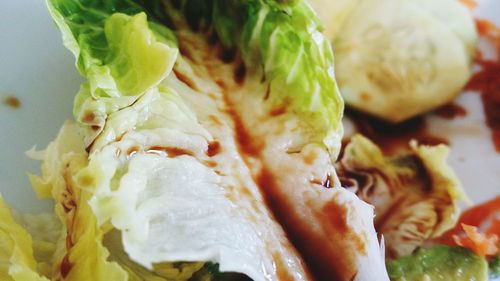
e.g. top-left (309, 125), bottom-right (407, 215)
top-left (47, 0), bottom-right (178, 146)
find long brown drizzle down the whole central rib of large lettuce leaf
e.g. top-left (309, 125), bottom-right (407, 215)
top-left (175, 25), bottom-right (363, 280)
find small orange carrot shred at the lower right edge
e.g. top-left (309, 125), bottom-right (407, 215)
top-left (453, 223), bottom-right (498, 257)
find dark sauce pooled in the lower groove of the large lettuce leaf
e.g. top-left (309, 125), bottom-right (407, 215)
top-left (256, 169), bottom-right (366, 280)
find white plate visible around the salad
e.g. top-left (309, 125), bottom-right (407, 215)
top-left (0, 0), bottom-right (500, 212)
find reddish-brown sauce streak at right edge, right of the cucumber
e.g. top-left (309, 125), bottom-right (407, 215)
top-left (465, 19), bottom-right (500, 153)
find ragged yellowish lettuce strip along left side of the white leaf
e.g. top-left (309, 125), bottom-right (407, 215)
top-left (27, 122), bottom-right (127, 281)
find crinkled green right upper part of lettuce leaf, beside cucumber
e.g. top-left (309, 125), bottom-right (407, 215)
top-left (162, 0), bottom-right (343, 153)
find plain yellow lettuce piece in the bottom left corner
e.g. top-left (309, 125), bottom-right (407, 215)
top-left (0, 195), bottom-right (49, 281)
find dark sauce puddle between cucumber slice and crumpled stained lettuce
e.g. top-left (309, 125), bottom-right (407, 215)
top-left (345, 109), bottom-right (449, 155)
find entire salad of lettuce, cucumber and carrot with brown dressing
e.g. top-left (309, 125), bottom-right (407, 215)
top-left (0, 0), bottom-right (500, 281)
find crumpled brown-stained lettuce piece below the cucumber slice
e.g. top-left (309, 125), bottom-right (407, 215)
top-left (337, 135), bottom-right (468, 258)
